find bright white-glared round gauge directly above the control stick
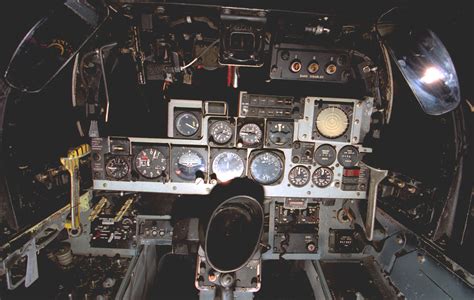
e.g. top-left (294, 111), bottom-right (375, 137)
top-left (212, 152), bottom-right (245, 182)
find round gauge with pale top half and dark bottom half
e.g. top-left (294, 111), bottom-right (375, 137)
top-left (174, 149), bottom-right (206, 181)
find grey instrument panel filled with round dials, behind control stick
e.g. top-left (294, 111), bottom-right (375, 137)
top-left (92, 93), bottom-right (371, 199)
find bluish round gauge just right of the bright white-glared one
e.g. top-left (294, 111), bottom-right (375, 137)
top-left (250, 152), bottom-right (283, 184)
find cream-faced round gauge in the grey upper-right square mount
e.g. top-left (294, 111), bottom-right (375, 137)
top-left (316, 106), bottom-right (349, 139)
